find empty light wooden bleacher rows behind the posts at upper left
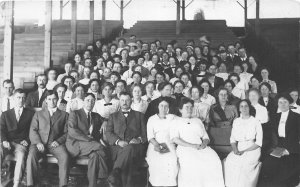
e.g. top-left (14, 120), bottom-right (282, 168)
top-left (0, 20), bottom-right (121, 88)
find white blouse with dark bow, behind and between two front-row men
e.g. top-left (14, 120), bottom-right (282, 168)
top-left (93, 99), bottom-right (120, 119)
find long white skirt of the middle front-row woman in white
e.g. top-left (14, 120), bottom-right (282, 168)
top-left (177, 146), bottom-right (224, 187)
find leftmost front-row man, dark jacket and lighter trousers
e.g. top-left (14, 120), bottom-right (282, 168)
top-left (0, 89), bottom-right (34, 187)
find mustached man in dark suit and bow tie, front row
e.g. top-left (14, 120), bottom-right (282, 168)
top-left (106, 92), bottom-right (147, 187)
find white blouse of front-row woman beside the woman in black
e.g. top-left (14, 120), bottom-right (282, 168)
top-left (230, 116), bottom-right (263, 147)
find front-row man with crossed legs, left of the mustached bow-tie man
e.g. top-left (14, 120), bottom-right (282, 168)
top-left (66, 93), bottom-right (108, 187)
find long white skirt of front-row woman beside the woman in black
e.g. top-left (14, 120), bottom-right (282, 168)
top-left (223, 142), bottom-right (261, 187)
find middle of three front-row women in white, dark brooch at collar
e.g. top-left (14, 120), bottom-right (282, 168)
top-left (170, 98), bottom-right (224, 187)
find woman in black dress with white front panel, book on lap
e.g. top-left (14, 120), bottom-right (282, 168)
top-left (261, 94), bottom-right (300, 186)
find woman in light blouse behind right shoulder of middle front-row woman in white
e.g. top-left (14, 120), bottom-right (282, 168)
top-left (190, 86), bottom-right (210, 127)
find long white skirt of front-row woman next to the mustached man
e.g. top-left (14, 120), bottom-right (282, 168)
top-left (146, 143), bottom-right (178, 186)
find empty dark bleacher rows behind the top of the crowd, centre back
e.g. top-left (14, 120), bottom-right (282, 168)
top-left (117, 20), bottom-right (239, 47)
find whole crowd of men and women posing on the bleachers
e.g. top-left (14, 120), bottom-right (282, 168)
top-left (0, 35), bottom-right (300, 187)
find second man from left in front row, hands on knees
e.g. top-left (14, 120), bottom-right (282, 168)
top-left (27, 91), bottom-right (69, 186)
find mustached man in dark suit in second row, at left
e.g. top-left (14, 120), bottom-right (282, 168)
top-left (25, 74), bottom-right (47, 108)
